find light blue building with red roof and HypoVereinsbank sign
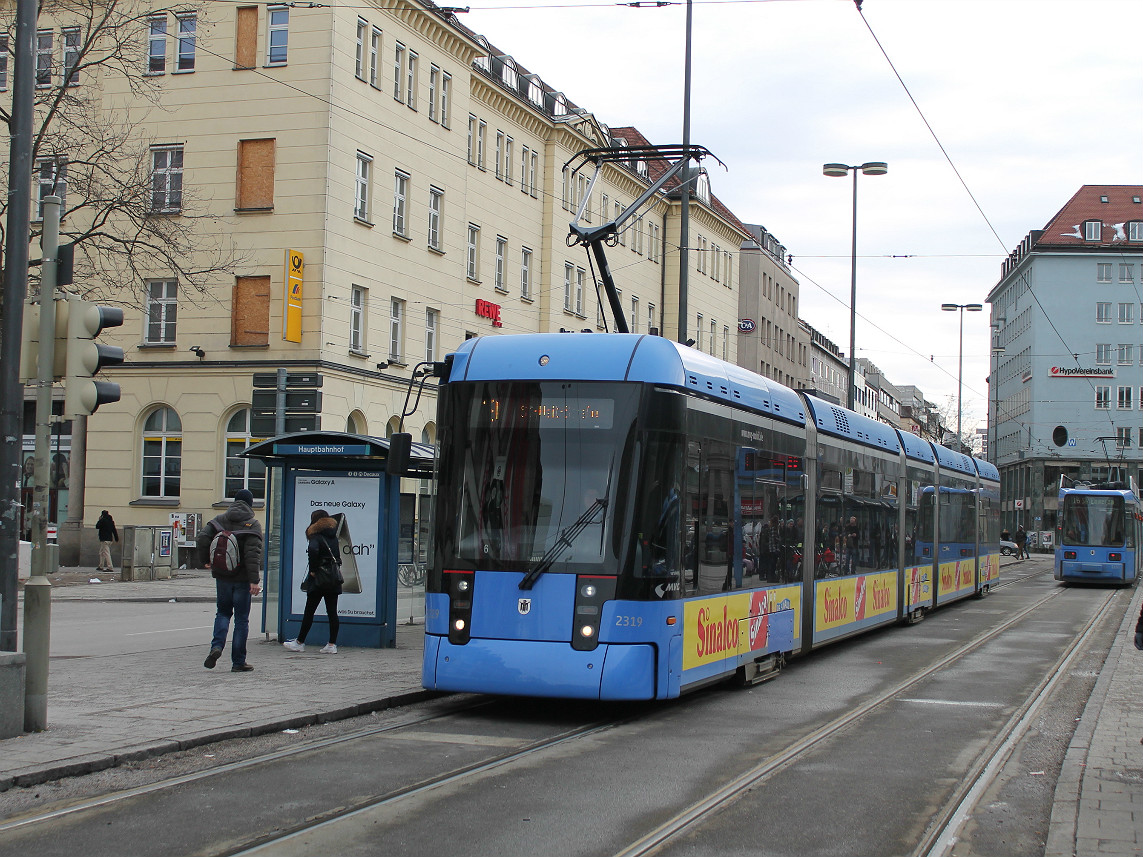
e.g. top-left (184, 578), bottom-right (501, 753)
top-left (988, 185), bottom-right (1143, 531)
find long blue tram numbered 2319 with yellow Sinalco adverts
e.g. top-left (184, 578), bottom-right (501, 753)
top-left (423, 334), bottom-right (999, 699)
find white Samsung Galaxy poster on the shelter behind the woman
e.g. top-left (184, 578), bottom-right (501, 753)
top-left (289, 473), bottom-right (382, 618)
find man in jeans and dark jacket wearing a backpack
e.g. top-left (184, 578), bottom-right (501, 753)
top-left (194, 488), bottom-right (262, 673)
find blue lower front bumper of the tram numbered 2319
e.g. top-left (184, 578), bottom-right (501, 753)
top-left (422, 634), bottom-right (655, 699)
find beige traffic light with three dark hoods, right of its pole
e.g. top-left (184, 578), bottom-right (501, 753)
top-left (64, 297), bottom-right (123, 417)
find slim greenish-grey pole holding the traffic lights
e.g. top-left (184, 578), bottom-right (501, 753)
top-left (24, 195), bottom-right (61, 732)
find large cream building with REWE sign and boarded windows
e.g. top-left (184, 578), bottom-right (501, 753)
top-left (13, 0), bottom-right (754, 559)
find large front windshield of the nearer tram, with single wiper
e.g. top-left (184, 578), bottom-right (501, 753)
top-left (441, 382), bottom-right (638, 571)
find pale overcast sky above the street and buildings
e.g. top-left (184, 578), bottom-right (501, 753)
top-left (463, 0), bottom-right (1143, 432)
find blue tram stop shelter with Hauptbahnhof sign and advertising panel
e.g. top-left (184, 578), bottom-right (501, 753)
top-left (240, 432), bottom-right (433, 648)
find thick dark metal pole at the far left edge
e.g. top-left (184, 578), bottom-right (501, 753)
top-left (0, 0), bottom-right (37, 651)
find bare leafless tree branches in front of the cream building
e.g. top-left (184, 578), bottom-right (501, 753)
top-left (0, 0), bottom-right (241, 306)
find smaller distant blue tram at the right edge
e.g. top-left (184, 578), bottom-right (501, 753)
top-left (1055, 476), bottom-right (1143, 586)
